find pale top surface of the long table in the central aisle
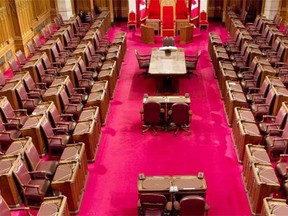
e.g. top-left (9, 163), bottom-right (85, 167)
top-left (148, 48), bottom-right (187, 75)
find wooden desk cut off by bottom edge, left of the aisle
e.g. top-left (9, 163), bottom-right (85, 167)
top-left (37, 195), bottom-right (70, 216)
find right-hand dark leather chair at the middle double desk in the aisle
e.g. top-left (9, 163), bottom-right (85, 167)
top-left (168, 103), bottom-right (192, 136)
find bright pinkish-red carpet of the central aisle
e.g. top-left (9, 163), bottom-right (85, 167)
top-left (79, 23), bottom-right (251, 216)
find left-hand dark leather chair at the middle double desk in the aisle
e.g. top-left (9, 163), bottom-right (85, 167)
top-left (140, 101), bottom-right (164, 135)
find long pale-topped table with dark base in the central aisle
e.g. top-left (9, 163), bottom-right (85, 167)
top-left (148, 48), bottom-right (187, 92)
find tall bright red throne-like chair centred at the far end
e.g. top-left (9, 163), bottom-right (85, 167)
top-left (161, 6), bottom-right (175, 36)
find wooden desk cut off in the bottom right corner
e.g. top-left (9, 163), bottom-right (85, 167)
top-left (260, 197), bottom-right (288, 216)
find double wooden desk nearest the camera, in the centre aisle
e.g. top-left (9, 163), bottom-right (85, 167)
top-left (138, 175), bottom-right (207, 201)
